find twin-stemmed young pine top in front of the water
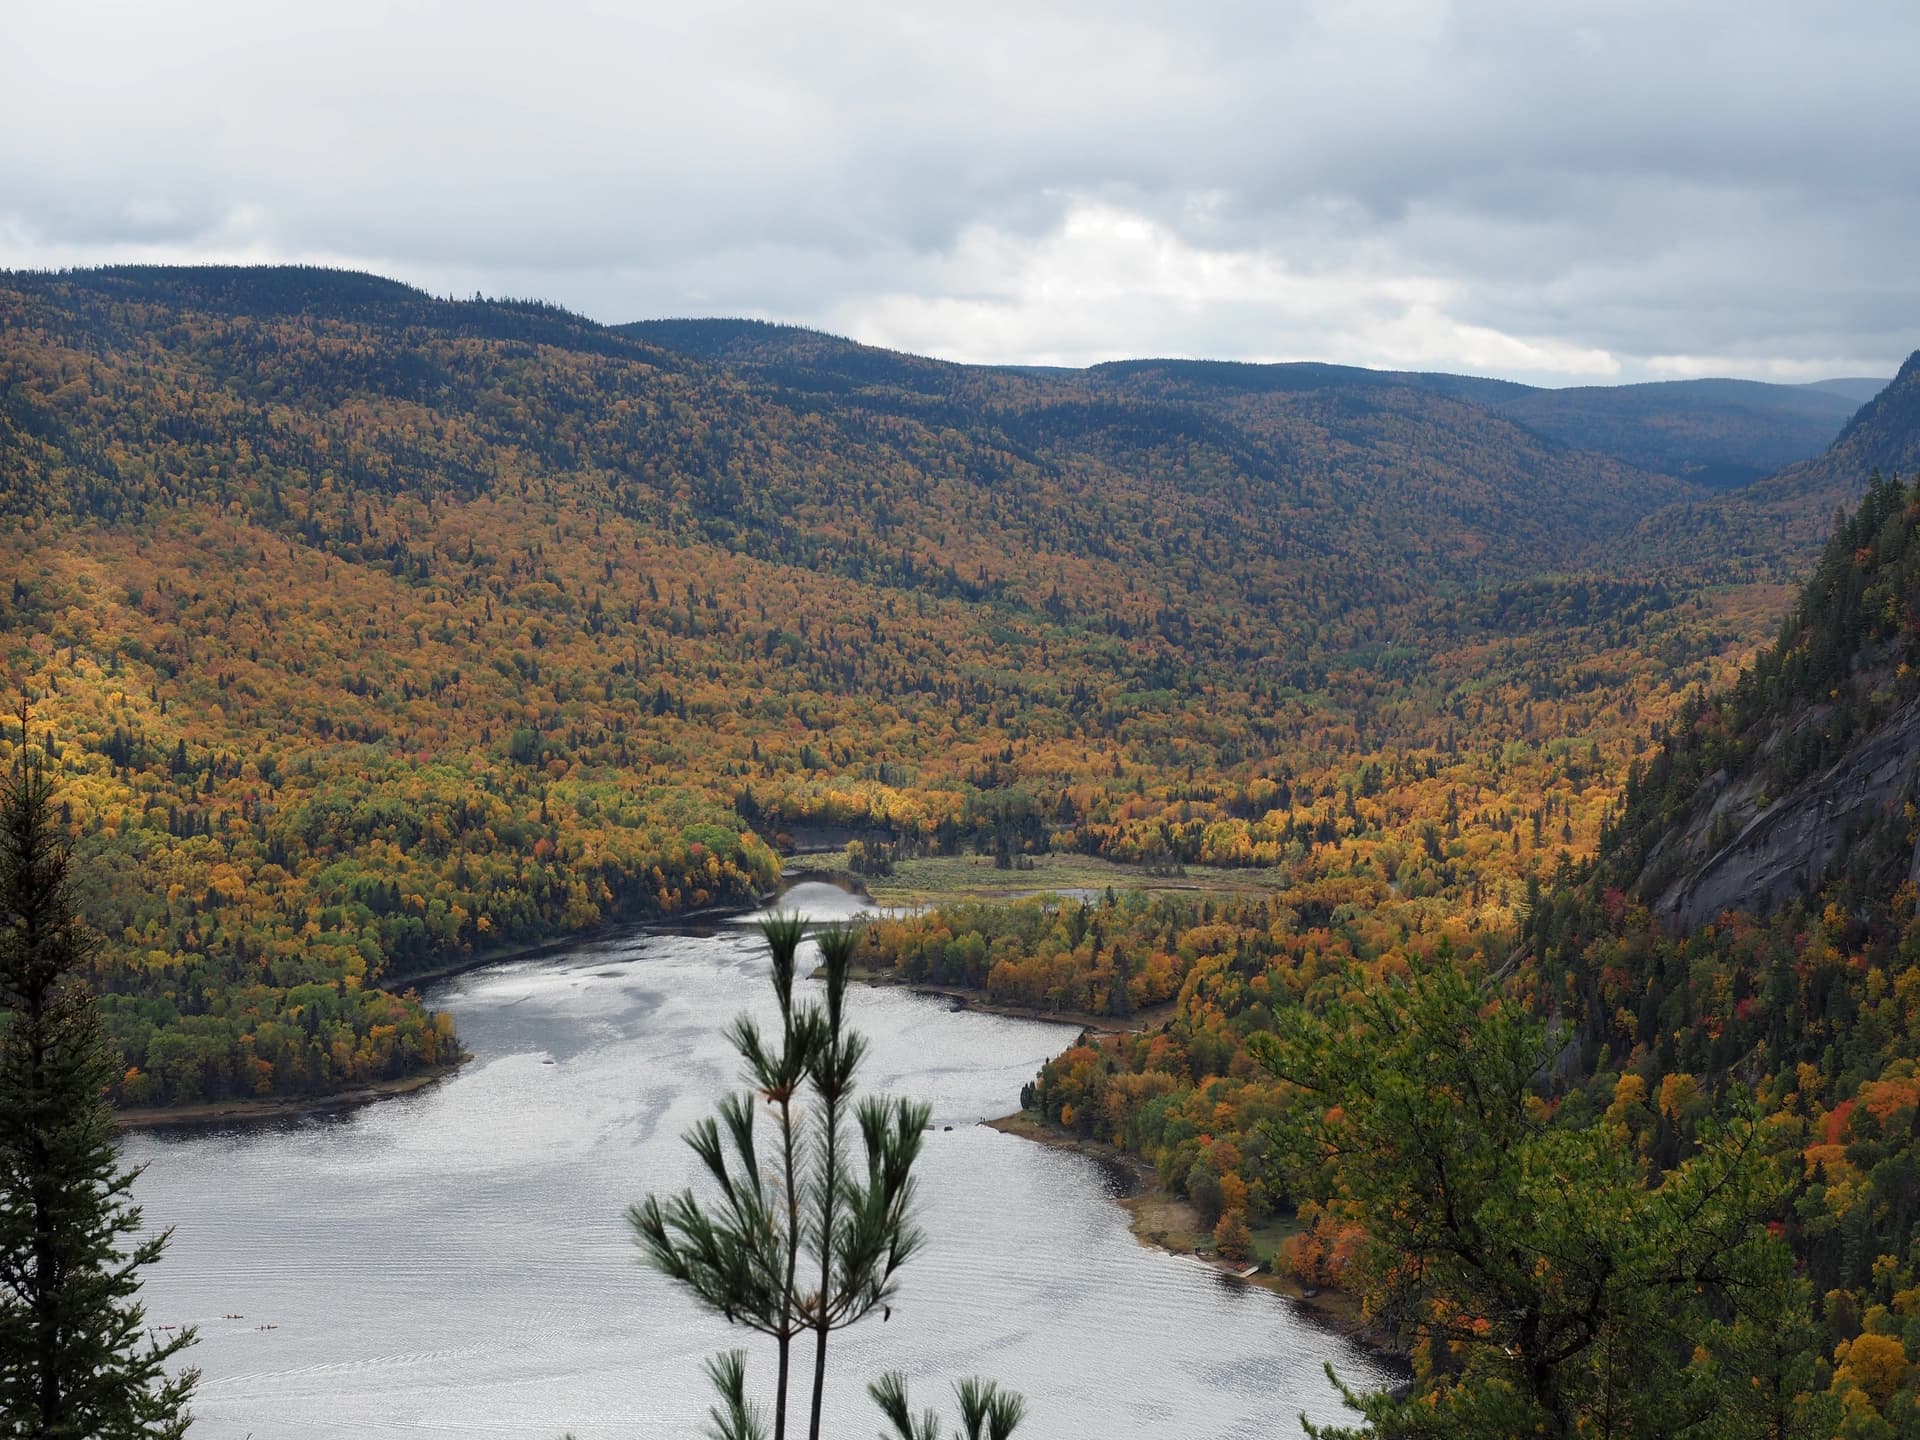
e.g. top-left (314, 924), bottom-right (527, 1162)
top-left (628, 916), bottom-right (1021, 1440)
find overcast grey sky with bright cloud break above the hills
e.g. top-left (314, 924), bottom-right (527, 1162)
top-left (0, 0), bottom-right (1920, 384)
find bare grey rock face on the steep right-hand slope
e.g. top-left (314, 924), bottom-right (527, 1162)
top-left (1644, 701), bottom-right (1920, 929)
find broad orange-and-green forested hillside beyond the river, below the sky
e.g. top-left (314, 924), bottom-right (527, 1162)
top-left (0, 267), bottom-right (1912, 1102)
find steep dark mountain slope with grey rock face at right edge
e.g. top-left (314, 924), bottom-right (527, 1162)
top-left (1489, 480), bottom-right (1920, 1413)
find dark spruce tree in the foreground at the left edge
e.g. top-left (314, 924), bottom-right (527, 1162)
top-left (0, 712), bottom-right (198, 1440)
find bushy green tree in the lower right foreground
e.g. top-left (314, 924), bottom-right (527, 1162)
top-left (1252, 958), bottom-right (1805, 1438)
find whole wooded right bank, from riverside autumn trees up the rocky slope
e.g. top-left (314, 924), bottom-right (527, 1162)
top-left (948, 478), bottom-right (1920, 1436)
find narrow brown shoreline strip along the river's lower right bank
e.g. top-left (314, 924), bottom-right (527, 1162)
top-left (979, 1110), bottom-right (1411, 1365)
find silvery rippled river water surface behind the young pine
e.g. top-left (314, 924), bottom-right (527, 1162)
top-left (127, 885), bottom-right (1377, 1440)
